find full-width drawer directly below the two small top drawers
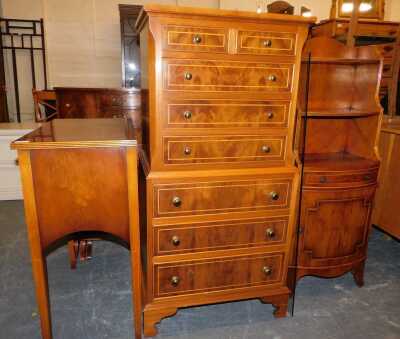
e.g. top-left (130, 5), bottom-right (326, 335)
top-left (164, 60), bottom-right (293, 92)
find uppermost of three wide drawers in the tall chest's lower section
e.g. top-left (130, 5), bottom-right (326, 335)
top-left (154, 178), bottom-right (291, 217)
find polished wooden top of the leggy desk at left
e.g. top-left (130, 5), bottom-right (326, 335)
top-left (11, 118), bottom-right (137, 149)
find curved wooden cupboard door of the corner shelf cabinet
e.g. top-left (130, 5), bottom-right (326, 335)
top-left (299, 186), bottom-right (375, 267)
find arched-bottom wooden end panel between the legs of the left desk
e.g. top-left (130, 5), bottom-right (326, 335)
top-left (31, 148), bottom-right (129, 248)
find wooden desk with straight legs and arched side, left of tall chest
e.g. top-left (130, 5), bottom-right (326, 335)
top-left (11, 119), bottom-right (142, 339)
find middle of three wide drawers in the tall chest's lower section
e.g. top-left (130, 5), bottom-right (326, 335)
top-left (154, 217), bottom-right (288, 255)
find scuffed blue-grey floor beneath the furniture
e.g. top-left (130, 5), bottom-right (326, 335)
top-left (0, 201), bottom-right (400, 339)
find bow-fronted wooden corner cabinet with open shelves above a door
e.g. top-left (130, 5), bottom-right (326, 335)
top-left (292, 37), bottom-right (382, 287)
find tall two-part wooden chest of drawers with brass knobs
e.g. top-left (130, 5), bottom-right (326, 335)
top-left (137, 6), bottom-right (312, 336)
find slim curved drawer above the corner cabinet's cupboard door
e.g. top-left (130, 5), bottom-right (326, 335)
top-left (304, 169), bottom-right (378, 187)
